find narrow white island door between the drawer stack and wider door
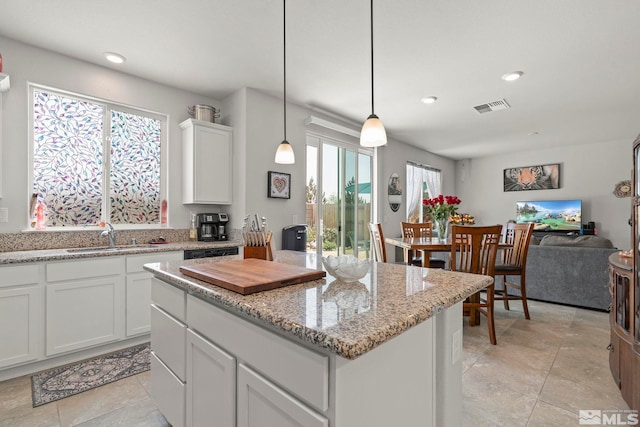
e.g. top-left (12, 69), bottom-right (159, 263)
top-left (185, 330), bottom-right (236, 427)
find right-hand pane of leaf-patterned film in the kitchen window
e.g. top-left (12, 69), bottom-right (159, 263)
top-left (109, 110), bottom-right (162, 224)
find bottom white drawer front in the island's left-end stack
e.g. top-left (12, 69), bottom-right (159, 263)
top-left (150, 352), bottom-right (185, 427)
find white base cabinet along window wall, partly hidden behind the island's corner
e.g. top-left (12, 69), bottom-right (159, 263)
top-left (125, 251), bottom-right (184, 337)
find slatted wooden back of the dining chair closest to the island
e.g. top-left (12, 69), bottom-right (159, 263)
top-left (450, 225), bottom-right (502, 277)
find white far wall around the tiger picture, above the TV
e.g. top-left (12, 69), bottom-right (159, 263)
top-left (456, 139), bottom-right (635, 249)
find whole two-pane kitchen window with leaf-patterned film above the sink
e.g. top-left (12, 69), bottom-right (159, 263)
top-left (30, 85), bottom-right (166, 227)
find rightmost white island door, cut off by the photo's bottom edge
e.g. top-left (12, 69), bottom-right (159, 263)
top-left (238, 363), bottom-right (329, 427)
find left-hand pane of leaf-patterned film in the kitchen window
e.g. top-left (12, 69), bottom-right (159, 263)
top-left (33, 90), bottom-right (104, 227)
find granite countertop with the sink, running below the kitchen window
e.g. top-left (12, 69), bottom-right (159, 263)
top-left (0, 240), bottom-right (244, 265)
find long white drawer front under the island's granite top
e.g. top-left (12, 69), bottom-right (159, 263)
top-left (187, 295), bottom-right (329, 411)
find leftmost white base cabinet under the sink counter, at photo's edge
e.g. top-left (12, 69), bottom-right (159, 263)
top-left (0, 264), bottom-right (41, 368)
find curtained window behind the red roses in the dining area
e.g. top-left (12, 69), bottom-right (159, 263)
top-left (407, 162), bottom-right (442, 222)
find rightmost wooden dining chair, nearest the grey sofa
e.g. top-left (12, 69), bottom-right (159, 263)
top-left (494, 223), bottom-right (534, 319)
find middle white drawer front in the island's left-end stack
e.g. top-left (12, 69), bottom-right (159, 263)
top-left (151, 305), bottom-right (187, 381)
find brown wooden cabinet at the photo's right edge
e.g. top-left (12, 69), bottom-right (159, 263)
top-left (609, 136), bottom-right (640, 410)
